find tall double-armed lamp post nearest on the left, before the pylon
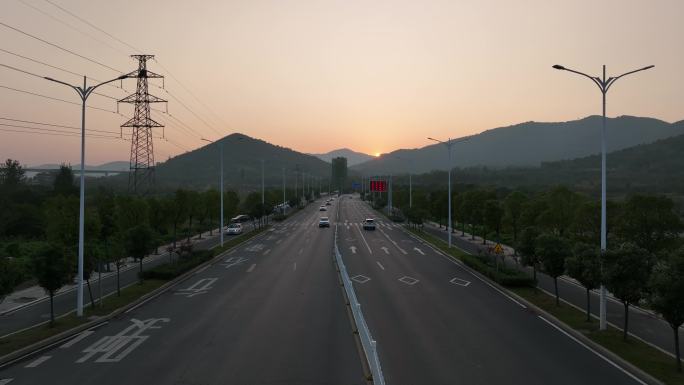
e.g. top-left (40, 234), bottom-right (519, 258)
top-left (43, 75), bottom-right (128, 317)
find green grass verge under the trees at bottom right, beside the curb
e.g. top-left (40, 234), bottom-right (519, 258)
top-left (510, 287), bottom-right (684, 385)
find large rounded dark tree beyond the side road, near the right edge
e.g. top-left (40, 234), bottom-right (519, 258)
top-left (618, 194), bottom-right (682, 253)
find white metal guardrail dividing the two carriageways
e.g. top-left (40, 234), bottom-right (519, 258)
top-left (335, 225), bottom-right (385, 385)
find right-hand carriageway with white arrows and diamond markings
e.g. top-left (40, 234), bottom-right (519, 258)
top-left (339, 198), bottom-right (639, 385)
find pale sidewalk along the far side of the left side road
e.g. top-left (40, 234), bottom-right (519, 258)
top-left (0, 229), bottom-right (219, 315)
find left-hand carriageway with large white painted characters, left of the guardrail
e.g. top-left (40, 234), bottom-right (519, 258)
top-left (0, 201), bottom-right (364, 385)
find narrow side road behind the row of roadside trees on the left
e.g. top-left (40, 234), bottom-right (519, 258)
top-left (0, 226), bottom-right (251, 338)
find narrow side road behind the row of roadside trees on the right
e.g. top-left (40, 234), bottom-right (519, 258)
top-left (424, 225), bottom-right (684, 354)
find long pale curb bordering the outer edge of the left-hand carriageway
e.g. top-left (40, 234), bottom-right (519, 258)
top-left (0, 225), bottom-right (267, 369)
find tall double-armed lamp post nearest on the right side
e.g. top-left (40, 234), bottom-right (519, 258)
top-left (553, 64), bottom-right (655, 330)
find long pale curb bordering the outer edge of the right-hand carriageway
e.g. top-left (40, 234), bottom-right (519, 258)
top-left (402, 227), bottom-right (665, 385)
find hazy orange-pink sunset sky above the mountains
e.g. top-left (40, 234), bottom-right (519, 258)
top-left (0, 0), bottom-right (684, 164)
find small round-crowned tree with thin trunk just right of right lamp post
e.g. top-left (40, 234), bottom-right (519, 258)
top-left (603, 243), bottom-right (652, 341)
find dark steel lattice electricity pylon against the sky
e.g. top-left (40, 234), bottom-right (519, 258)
top-left (119, 55), bottom-right (166, 194)
